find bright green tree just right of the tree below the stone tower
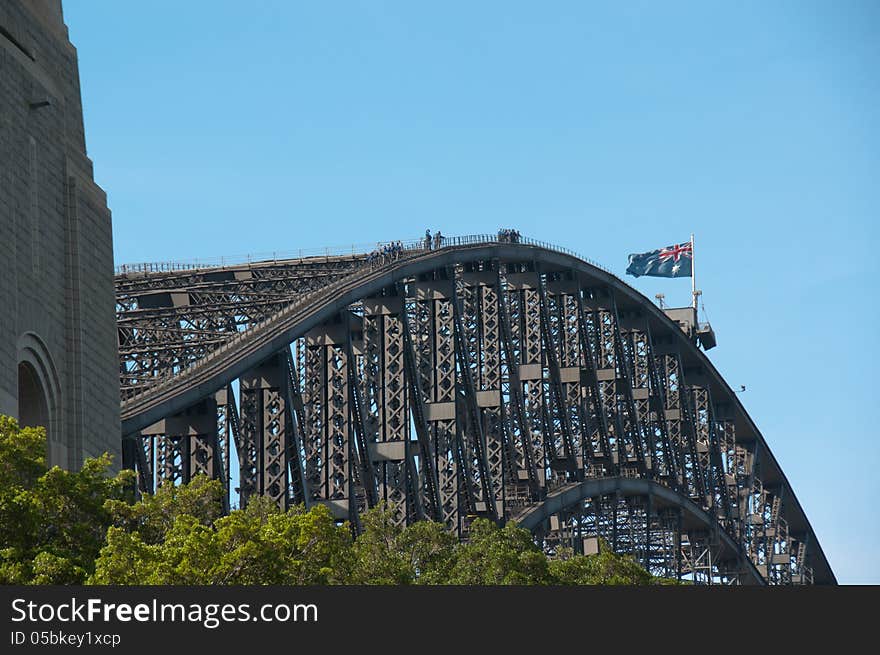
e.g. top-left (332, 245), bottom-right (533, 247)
top-left (90, 484), bottom-right (351, 585)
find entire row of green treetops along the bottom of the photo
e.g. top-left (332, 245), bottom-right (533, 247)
top-left (0, 417), bottom-right (658, 585)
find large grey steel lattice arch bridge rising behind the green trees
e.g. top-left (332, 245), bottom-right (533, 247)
top-left (116, 235), bottom-right (836, 584)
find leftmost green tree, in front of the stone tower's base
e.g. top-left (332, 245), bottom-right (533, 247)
top-left (0, 416), bottom-right (134, 584)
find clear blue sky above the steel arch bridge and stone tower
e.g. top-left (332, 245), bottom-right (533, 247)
top-left (64, 0), bottom-right (880, 583)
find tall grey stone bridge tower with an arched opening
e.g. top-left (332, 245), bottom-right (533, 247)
top-left (0, 0), bottom-right (120, 469)
